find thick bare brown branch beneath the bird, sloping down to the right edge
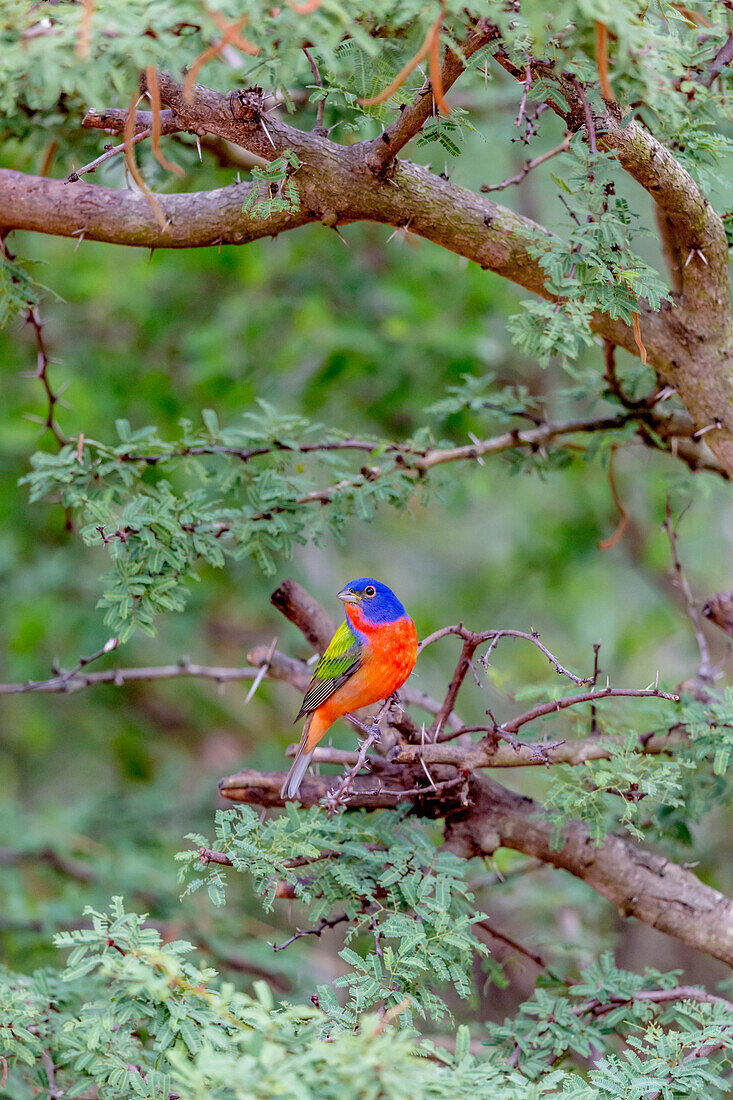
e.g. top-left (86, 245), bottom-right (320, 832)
top-left (219, 766), bottom-right (733, 966)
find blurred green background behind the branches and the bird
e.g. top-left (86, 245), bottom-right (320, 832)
top-left (0, 107), bottom-right (733, 1015)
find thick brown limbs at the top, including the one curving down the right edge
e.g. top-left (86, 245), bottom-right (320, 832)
top-left (5, 67), bottom-right (733, 473)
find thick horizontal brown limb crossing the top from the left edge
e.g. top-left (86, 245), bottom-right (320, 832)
top-left (0, 74), bottom-right (668, 355)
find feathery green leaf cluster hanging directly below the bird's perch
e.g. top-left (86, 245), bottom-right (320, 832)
top-left (178, 804), bottom-right (489, 1027)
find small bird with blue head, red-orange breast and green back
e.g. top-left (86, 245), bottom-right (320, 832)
top-left (281, 576), bottom-right (417, 799)
